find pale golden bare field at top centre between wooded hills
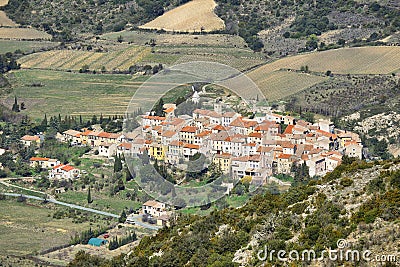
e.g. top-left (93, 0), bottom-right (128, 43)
top-left (139, 0), bottom-right (225, 32)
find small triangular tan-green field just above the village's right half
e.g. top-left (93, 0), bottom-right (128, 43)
top-left (249, 71), bottom-right (327, 100)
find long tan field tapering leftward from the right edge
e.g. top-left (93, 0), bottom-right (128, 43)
top-left (251, 46), bottom-right (400, 76)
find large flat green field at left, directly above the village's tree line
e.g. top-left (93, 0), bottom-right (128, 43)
top-left (3, 70), bottom-right (142, 119)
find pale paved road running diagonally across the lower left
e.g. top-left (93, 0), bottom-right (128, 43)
top-left (2, 193), bottom-right (161, 230)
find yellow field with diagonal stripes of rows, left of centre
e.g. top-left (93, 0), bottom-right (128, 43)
top-left (18, 46), bottom-right (151, 71)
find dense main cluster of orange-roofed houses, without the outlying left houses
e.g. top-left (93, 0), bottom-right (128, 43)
top-left (132, 102), bottom-right (363, 183)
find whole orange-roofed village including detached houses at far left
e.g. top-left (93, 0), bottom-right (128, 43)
top-left (21, 94), bottom-right (363, 184)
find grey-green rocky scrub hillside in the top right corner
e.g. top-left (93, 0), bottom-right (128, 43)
top-left (216, 0), bottom-right (400, 52)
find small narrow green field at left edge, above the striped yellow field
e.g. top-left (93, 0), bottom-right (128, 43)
top-left (0, 40), bottom-right (58, 54)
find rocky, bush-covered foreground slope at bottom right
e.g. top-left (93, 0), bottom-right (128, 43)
top-left (69, 159), bottom-right (400, 267)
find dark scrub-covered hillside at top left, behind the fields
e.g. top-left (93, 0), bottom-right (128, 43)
top-left (3, 0), bottom-right (188, 41)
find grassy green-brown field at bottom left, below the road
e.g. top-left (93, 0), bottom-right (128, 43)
top-left (0, 199), bottom-right (104, 255)
